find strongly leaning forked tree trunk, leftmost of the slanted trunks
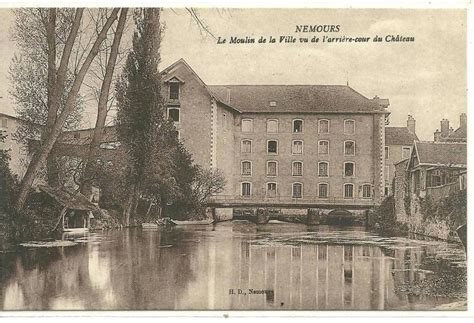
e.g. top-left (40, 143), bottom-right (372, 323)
top-left (15, 8), bottom-right (119, 212)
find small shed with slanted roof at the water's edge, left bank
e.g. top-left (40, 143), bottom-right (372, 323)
top-left (38, 185), bottom-right (98, 231)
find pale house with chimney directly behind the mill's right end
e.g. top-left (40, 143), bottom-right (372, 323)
top-left (384, 115), bottom-right (418, 196)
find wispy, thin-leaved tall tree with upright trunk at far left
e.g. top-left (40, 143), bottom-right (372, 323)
top-left (9, 8), bottom-right (83, 186)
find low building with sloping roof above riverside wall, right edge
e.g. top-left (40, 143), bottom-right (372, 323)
top-left (407, 142), bottom-right (467, 199)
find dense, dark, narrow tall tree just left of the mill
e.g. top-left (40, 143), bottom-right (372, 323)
top-left (116, 8), bottom-right (165, 225)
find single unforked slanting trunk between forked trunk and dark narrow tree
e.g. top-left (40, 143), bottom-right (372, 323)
top-left (81, 8), bottom-right (128, 197)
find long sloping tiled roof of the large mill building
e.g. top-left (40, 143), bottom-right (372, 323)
top-left (208, 85), bottom-right (384, 113)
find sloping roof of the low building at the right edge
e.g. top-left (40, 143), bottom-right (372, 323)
top-left (415, 142), bottom-right (467, 167)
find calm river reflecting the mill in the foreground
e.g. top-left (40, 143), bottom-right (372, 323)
top-left (0, 221), bottom-right (467, 310)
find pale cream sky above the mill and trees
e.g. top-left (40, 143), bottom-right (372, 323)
top-left (0, 9), bottom-right (467, 140)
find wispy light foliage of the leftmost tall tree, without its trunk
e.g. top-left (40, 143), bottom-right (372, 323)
top-left (9, 8), bottom-right (84, 142)
